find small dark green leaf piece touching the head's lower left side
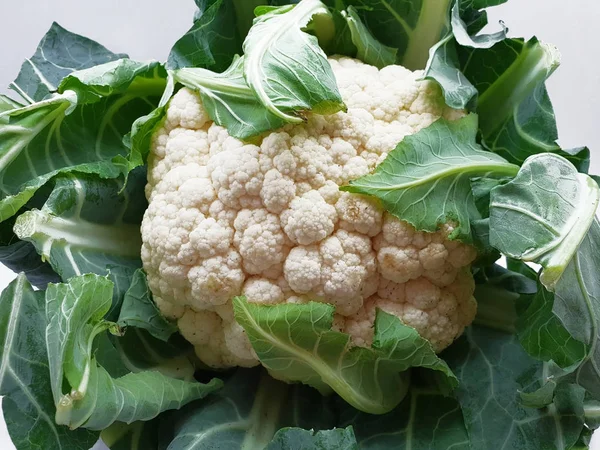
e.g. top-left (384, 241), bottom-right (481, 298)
top-left (117, 269), bottom-right (177, 342)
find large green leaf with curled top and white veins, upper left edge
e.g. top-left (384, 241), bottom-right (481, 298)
top-left (0, 62), bottom-right (164, 225)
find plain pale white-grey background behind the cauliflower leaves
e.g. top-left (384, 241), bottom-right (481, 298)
top-left (0, 0), bottom-right (600, 450)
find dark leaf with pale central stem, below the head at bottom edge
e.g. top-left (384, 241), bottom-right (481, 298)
top-left (162, 369), bottom-right (335, 450)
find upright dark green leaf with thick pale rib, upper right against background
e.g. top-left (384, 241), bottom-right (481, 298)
top-left (460, 38), bottom-right (579, 164)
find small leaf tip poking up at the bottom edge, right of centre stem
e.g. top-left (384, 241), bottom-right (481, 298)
top-left (265, 426), bottom-right (358, 450)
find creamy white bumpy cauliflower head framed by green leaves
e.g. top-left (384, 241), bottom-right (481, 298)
top-left (142, 58), bottom-right (476, 367)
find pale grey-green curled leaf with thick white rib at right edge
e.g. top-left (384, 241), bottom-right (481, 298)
top-left (490, 153), bottom-right (600, 290)
